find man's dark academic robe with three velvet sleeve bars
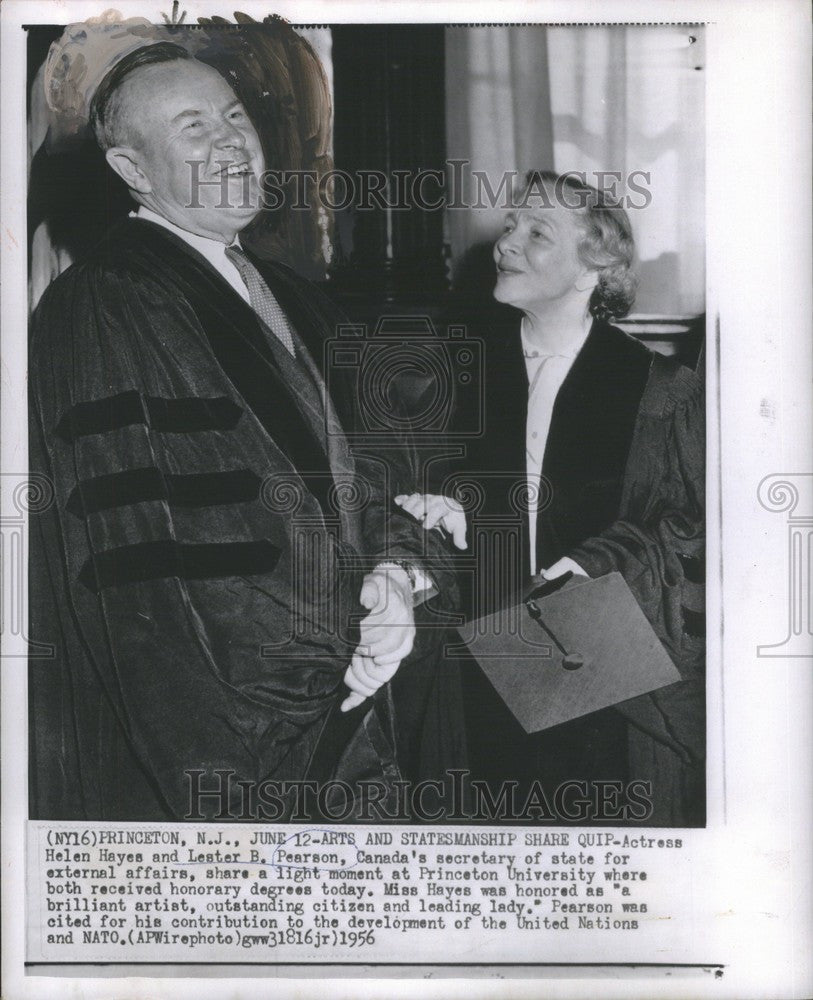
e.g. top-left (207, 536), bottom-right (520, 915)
top-left (30, 219), bottom-right (461, 820)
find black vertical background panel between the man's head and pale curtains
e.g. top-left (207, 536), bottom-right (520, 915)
top-left (332, 25), bottom-right (448, 308)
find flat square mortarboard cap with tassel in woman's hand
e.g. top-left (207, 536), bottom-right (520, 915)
top-left (460, 573), bottom-right (680, 733)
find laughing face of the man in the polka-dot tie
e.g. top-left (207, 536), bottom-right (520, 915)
top-left (121, 60), bottom-right (265, 243)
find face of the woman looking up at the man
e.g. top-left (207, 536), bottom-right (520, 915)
top-left (494, 203), bottom-right (597, 313)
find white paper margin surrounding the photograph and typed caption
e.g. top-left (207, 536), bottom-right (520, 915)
top-left (0, 0), bottom-right (813, 1000)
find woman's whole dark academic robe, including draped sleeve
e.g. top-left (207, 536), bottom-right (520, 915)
top-left (450, 310), bottom-right (705, 825)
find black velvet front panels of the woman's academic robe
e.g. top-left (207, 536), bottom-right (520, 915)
top-left (454, 320), bottom-right (652, 575)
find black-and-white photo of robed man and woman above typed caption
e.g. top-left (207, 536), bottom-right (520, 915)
top-left (28, 11), bottom-right (705, 826)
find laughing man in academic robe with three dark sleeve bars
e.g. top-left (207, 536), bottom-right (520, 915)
top-left (30, 43), bottom-right (460, 819)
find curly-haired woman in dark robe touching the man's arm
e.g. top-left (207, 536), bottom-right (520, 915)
top-left (396, 173), bottom-right (704, 825)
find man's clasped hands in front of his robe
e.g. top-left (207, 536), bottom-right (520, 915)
top-left (341, 566), bottom-right (415, 712)
